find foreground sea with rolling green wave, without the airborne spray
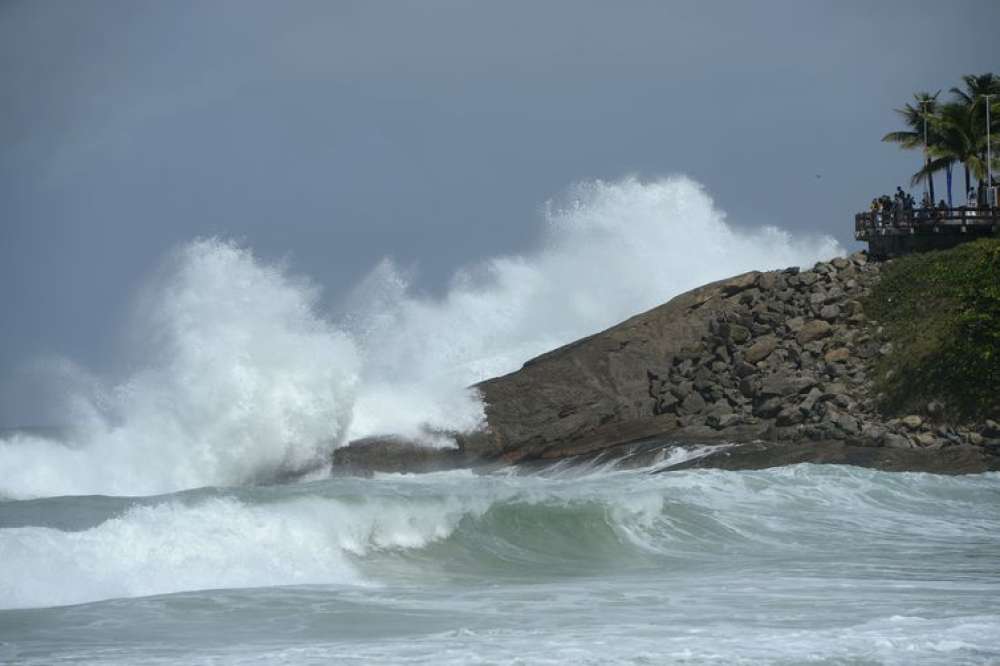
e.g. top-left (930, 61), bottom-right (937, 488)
top-left (0, 465), bottom-right (1000, 664)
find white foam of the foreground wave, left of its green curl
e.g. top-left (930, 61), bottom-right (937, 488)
top-left (0, 498), bottom-right (475, 608)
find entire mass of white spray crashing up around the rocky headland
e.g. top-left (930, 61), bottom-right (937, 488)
top-left (0, 178), bottom-right (842, 497)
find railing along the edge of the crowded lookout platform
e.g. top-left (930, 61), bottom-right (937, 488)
top-left (854, 207), bottom-right (1000, 241)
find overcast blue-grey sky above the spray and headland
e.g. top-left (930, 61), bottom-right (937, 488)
top-left (0, 0), bottom-right (1000, 420)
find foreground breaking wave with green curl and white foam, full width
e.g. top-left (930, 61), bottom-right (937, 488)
top-left (0, 465), bottom-right (1000, 608)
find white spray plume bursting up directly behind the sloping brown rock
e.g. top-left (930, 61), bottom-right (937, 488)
top-left (349, 178), bottom-right (843, 437)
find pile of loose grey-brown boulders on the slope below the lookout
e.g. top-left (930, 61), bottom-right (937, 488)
top-left (647, 253), bottom-right (1000, 448)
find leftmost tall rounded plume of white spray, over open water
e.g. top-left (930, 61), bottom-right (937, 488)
top-left (0, 239), bottom-right (358, 497)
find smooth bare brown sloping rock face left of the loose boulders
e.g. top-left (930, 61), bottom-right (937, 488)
top-left (476, 272), bottom-right (760, 461)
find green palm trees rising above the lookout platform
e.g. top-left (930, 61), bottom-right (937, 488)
top-left (882, 73), bottom-right (1000, 201)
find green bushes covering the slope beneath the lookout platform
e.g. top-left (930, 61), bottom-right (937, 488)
top-left (864, 238), bottom-right (1000, 420)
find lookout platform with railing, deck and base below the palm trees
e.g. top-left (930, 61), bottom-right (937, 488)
top-left (854, 207), bottom-right (1000, 259)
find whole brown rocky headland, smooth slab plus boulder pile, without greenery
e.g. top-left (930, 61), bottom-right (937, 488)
top-left (334, 246), bottom-right (1000, 473)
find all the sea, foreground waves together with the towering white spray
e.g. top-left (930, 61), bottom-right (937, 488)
top-left (0, 178), bottom-right (1000, 665)
